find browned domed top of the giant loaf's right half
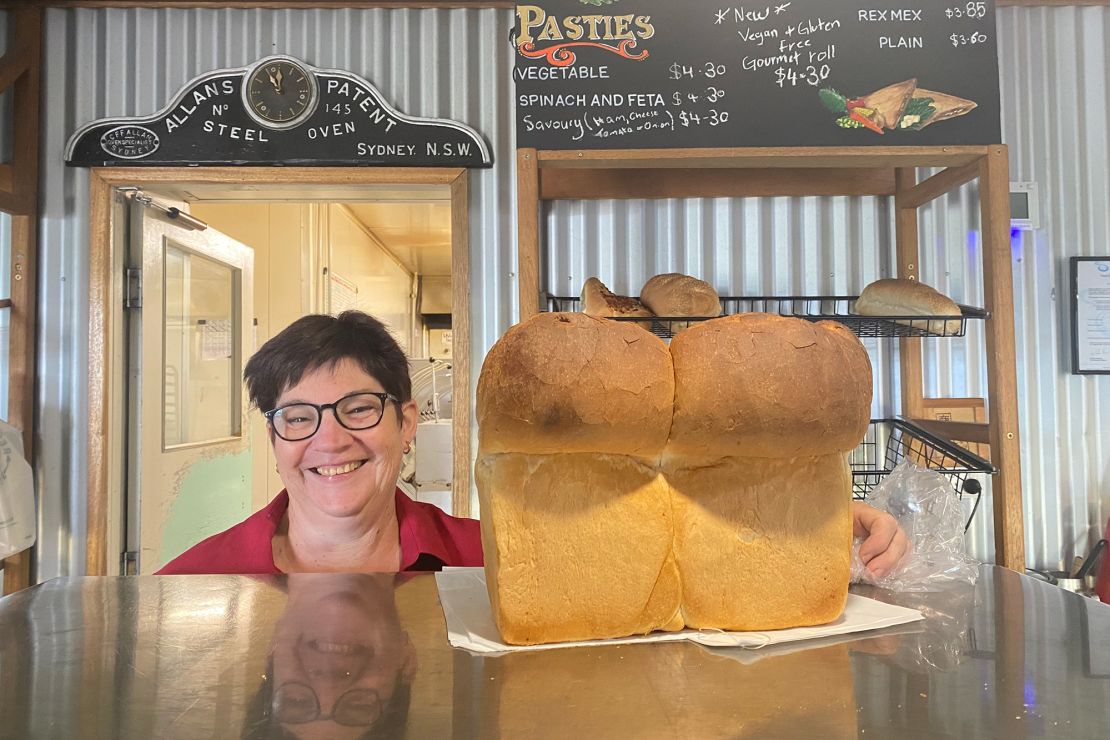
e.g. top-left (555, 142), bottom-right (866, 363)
top-left (667, 313), bottom-right (871, 459)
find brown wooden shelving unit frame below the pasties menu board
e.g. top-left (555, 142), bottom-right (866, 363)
top-left (516, 144), bottom-right (1025, 570)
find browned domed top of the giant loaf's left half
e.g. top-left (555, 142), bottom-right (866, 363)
top-left (477, 313), bottom-right (675, 459)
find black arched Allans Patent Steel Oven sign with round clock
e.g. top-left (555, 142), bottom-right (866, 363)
top-left (65, 55), bottom-right (493, 168)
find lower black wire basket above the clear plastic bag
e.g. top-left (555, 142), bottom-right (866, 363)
top-left (848, 418), bottom-right (998, 529)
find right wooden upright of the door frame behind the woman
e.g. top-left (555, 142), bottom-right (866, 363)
top-left (451, 170), bottom-right (472, 517)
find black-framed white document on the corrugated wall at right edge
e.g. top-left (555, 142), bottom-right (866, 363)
top-left (1070, 256), bottom-right (1110, 375)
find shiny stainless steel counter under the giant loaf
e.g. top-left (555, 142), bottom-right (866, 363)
top-left (0, 566), bottom-right (1110, 740)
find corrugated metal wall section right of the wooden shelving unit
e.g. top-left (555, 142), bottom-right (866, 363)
top-left (998, 8), bottom-right (1110, 567)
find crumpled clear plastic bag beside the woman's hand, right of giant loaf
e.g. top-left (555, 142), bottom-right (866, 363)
top-left (851, 460), bottom-right (979, 591)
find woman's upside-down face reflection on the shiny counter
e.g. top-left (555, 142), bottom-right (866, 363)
top-left (243, 574), bottom-right (416, 738)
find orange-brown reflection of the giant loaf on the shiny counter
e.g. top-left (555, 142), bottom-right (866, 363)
top-left (464, 643), bottom-right (856, 739)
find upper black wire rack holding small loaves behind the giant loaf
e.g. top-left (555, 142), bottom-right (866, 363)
top-left (547, 295), bottom-right (990, 339)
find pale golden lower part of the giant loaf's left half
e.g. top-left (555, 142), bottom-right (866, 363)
top-left (475, 454), bottom-right (683, 645)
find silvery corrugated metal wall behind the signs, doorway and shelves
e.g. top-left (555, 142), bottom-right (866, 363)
top-left (38, 8), bottom-right (1110, 579)
